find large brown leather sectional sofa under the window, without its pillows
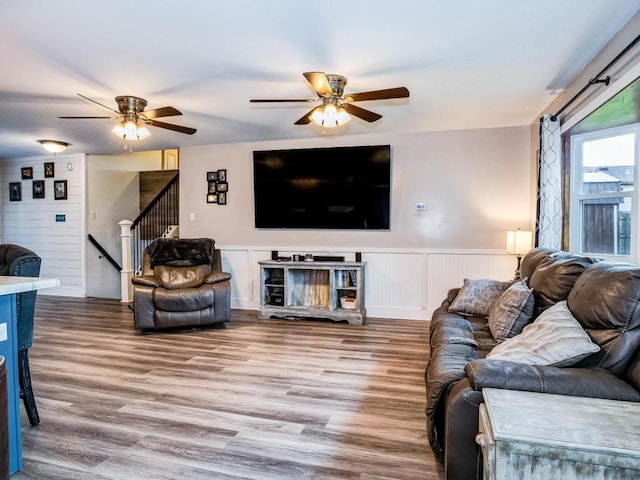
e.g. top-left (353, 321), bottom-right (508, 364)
top-left (425, 248), bottom-right (640, 480)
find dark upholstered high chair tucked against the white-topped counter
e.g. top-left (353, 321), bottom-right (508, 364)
top-left (0, 243), bottom-right (42, 425)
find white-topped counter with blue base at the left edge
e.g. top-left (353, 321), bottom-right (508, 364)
top-left (0, 276), bottom-right (60, 473)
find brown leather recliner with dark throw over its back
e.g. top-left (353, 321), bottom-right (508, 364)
top-left (132, 238), bottom-right (231, 330)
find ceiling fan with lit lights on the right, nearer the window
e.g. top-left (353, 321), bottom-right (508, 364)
top-left (249, 72), bottom-right (409, 127)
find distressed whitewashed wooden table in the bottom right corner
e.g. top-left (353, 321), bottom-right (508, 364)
top-left (476, 388), bottom-right (640, 480)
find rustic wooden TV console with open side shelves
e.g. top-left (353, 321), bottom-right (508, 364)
top-left (258, 260), bottom-right (366, 325)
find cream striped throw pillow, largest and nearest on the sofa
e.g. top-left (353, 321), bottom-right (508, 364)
top-left (487, 300), bottom-right (600, 367)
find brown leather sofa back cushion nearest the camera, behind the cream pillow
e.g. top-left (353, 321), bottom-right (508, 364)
top-left (567, 262), bottom-right (640, 377)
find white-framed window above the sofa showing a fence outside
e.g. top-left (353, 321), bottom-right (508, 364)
top-left (564, 79), bottom-right (640, 261)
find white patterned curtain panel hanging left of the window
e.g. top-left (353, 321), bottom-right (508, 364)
top-left (536, 115), bottom-right (562, 248)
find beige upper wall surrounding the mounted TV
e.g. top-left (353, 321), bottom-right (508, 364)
top-left (180, 126), bottom-right (531, 250)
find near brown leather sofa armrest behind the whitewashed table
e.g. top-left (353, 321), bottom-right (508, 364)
top-left (465, 359), bottom-right (640, 402)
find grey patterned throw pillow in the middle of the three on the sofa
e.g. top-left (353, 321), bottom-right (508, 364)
top-left (489, 280), bottom-right (535, 343)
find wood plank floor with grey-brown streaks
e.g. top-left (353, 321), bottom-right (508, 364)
top-left (12, 295), bottom-right (444, 480)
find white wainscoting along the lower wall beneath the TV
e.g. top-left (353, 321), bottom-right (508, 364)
top-left (218, 246), bottom-right (516, 320)
